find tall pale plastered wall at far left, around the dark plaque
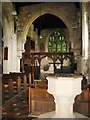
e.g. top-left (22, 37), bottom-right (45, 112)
top-left (2, 3), bottom-right (17, 74)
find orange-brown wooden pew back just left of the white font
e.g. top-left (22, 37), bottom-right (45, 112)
top-left (30, 88), bottom-right (55, 114)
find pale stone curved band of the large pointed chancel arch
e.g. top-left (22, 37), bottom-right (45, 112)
top-left (18, 7), bottom-right (73, 42)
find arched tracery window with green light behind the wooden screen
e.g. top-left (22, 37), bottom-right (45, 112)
top-left (48, 31), bottom-right (67, 52)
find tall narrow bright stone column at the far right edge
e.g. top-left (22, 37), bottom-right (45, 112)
top-left (81, 2), bottom-right (89, 76)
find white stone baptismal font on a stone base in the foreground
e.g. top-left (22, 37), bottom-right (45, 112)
top-left (39, 75), bottom-right (87, 118)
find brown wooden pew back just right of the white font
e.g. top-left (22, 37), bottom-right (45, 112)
top-left (74, 90), bottom-right (90, 117)
